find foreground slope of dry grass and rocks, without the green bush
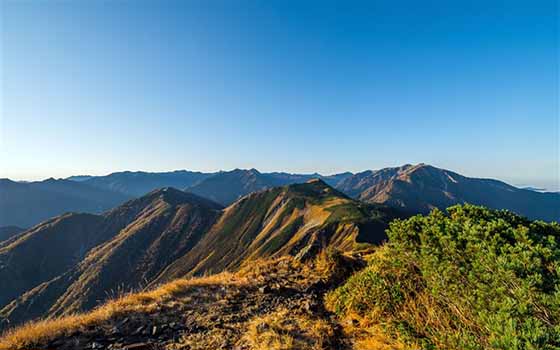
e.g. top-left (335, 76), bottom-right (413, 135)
top-left (0, 254), bottom-right (359, 350)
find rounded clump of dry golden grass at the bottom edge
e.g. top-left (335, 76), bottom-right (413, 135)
top-left (242, 309), bottom-right (334, 350)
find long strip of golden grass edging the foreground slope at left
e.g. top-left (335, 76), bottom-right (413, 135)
top-left (0, 273), bottom-right (247, 350)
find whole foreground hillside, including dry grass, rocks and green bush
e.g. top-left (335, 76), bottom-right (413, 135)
top-left (0, 204), bottom-right (560, 350)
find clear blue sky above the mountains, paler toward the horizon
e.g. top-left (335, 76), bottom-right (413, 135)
top-left (0, 0), bottom-right (559, 189)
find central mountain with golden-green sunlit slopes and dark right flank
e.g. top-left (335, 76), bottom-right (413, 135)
top-left (153, 180), bottom-right (397, 282)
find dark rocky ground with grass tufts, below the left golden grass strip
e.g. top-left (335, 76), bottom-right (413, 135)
top-left (7, 254), bottom-right (364, 350)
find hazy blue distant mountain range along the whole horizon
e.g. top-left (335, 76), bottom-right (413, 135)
top-left (0, 164), bottom-right (560, 227)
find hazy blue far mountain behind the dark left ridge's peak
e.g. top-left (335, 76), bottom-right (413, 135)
top-left (75, 170), bottom-right (212, 197)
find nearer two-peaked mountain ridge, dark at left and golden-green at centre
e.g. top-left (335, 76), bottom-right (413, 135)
top-left (0, 180), bottom-right (398, 325)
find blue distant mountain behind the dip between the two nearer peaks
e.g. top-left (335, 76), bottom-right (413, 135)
top-left (186, 169), bottom-right (352, 205)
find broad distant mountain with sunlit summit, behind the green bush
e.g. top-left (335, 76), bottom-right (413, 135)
top-left (337, 164), bottom-right (560, 221)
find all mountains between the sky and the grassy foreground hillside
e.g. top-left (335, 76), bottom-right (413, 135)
top-left (0, 164), bottom-right (560, 334)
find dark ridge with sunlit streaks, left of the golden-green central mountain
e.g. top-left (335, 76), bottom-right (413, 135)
top-left (0, 188), bottom-right (221, 323)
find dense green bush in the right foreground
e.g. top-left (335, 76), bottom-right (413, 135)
top-left (327, 205), bottom-right (560, 349)
